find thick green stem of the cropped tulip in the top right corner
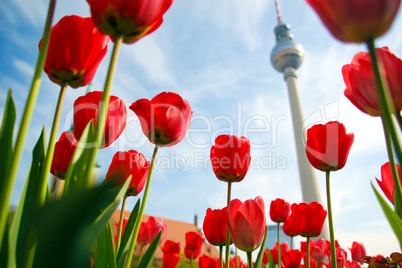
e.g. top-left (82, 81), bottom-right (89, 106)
top-left (366, 38), bottom-right (402, 165)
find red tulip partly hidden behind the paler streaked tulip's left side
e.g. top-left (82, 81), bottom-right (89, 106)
top-left (203, 207), bottom-right (231, 246)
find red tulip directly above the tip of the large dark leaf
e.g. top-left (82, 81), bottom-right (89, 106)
top-left (105, 150), bottom-right (150, 196)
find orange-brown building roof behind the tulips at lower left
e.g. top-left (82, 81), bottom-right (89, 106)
top-left (110, 209), bottom-right (219, 260)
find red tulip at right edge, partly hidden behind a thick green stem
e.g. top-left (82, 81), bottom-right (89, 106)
top-left (342, 47), bottom-right (402, 116)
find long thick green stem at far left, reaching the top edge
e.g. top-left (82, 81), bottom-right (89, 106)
top-left (0, 0), bottom-right (56, 250)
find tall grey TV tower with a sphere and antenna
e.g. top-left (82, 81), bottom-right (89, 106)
top-left (271, 0), bottom-right (329, 239)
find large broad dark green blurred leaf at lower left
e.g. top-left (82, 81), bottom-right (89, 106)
top-left (33, 177), bottom-right (130, 267)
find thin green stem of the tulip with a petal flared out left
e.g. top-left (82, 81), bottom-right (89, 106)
top-left (124, 145), bottom-right (159, 268)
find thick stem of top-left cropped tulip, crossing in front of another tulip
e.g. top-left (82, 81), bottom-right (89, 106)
top-left (84, 35), bottom-right (124, 188)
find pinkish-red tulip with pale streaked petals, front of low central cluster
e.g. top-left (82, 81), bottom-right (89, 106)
top-left (227, 196), bottom-right (266, 252)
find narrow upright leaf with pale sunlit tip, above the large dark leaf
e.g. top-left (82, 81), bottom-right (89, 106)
top-left (63, 120), bottom-right (95, 195)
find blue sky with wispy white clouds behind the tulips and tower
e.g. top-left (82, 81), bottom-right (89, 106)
top-left (0, 0), bottom-right (402, 255)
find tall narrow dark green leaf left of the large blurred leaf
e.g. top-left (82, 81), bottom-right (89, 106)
top-left (16, 127), bottom-right (46, 267)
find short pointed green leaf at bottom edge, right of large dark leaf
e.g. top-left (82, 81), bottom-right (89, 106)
top-left (95, 222), bottom-right (116, 268)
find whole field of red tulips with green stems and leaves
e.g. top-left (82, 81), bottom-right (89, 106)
top-left (0, 0), bottom-right (402, 268)
